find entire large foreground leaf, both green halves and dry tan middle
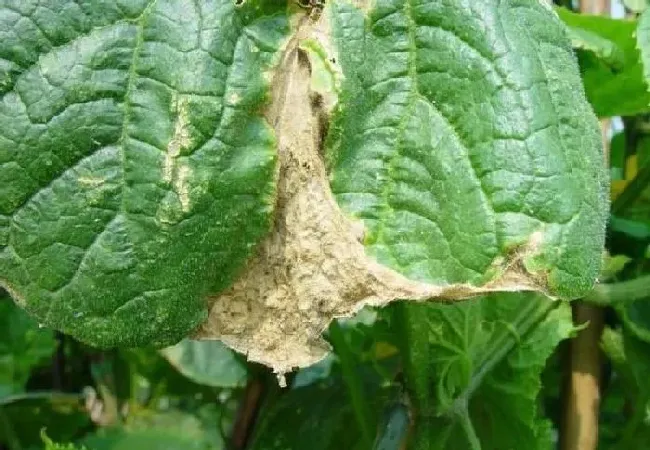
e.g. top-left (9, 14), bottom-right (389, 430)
top-left (0, 0), bottom-right (608, 372)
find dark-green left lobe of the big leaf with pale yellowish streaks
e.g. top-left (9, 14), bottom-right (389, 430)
top-left (0, 0), bottom-right (287, 346)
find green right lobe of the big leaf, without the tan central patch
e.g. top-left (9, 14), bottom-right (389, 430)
top-left (328, 0), bottom-right (608, 297)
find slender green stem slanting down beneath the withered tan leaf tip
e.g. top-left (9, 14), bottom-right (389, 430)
top-left (329, 320), bottom-right (376, 449)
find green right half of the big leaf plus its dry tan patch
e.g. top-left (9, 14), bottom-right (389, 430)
top-left (197, 0), bottom-right (608, 373)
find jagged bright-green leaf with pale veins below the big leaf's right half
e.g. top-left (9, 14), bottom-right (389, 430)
top-left (398, 294), bottom-right (574, 450)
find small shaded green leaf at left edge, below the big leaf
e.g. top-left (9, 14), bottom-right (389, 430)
top-left (0, 292), bottom-right (56, 399)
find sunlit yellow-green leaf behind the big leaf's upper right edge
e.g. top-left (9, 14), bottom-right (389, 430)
top-left (556, 8), bottom-right (650, 117)
